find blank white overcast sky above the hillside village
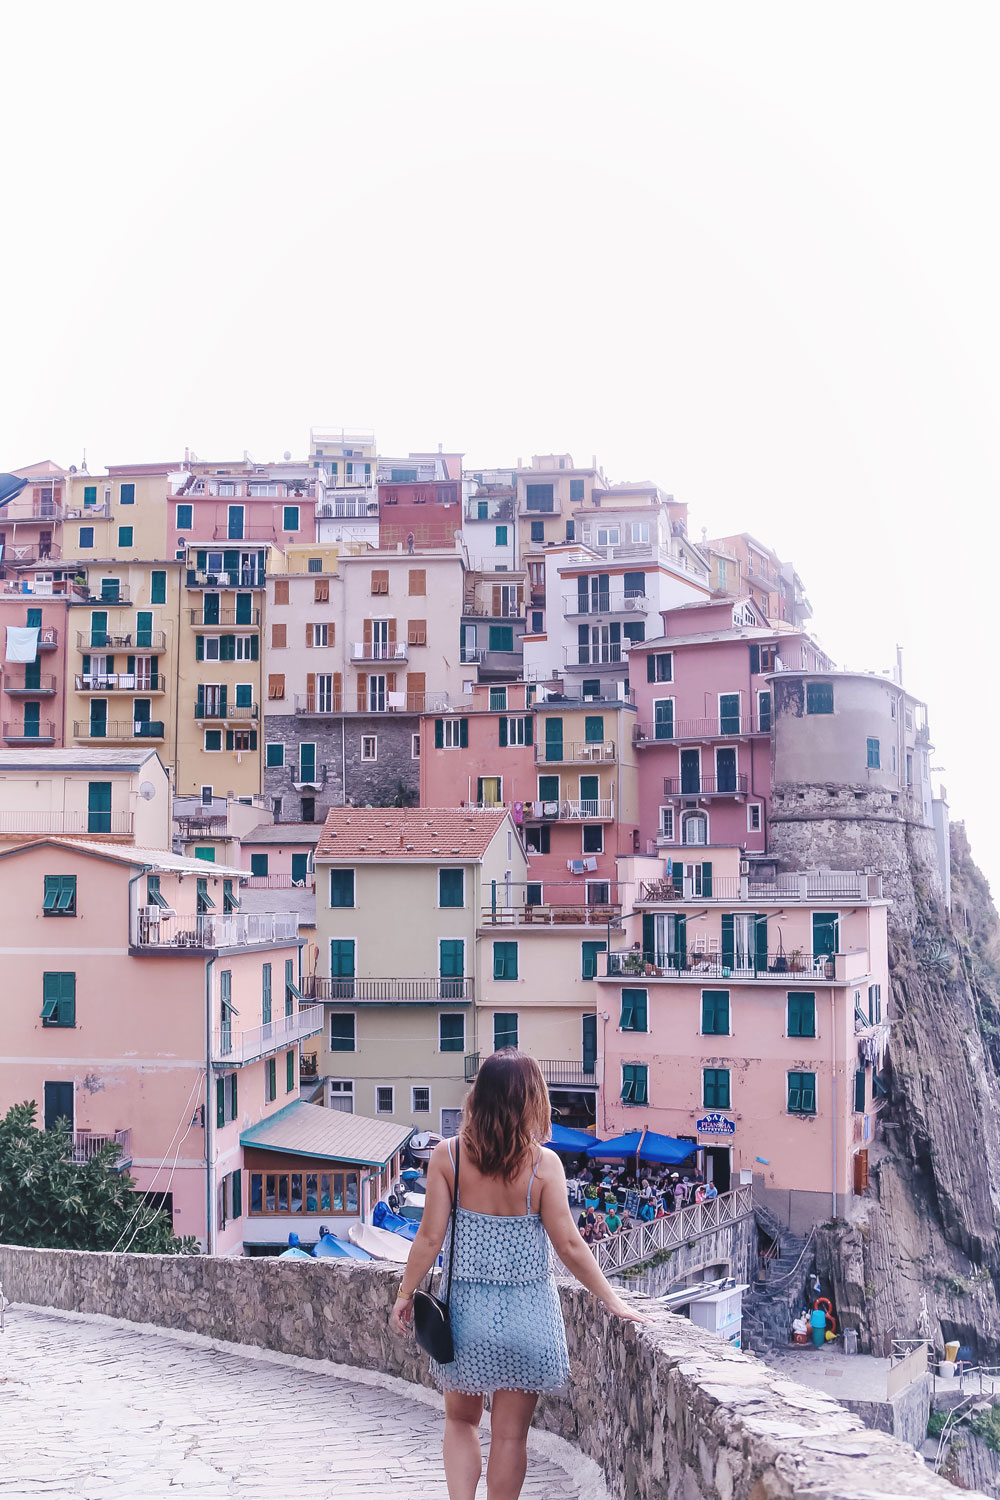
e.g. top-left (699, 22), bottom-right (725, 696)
top-left (0, 0), bottom-right (1000, 885)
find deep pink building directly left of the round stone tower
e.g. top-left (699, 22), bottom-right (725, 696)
top-left (628, 599), bottom-right (828, 857)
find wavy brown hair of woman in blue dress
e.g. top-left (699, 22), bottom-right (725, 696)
top-left (462, 1047), bottom-right (552, 1182)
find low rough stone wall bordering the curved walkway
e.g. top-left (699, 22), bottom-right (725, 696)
top-left (0, 1247), bottom-right (983, 1500)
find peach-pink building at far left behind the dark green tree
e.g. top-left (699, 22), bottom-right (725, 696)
top-left (0, 840), bottom-right (310, 1256)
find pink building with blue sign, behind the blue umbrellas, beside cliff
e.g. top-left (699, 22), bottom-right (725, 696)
top-left (598, 849), bottom-right (889, 1230)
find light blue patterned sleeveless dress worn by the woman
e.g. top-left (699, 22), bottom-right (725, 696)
top-left (430, 1142), bottom-right (570, 1395)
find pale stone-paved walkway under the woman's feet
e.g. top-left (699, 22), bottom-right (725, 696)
top-left (0, 1307), bottom-right (597, 1500)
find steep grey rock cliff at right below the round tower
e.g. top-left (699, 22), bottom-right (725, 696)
top-left (772, 788), bottom-right (1000, 1362)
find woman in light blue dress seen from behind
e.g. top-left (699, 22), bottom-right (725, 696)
top-left (391, 1047), bottom-right (646, 1500)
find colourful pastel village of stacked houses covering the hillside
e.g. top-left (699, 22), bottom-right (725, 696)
top-left (0, 429), bottom-right (949, 1256)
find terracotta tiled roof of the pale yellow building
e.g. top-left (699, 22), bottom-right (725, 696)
top-left (316, 807), bottom-right (507, 861)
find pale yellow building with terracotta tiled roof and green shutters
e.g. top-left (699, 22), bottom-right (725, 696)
top-left (307, 807), bottom-right (526, 1134)
